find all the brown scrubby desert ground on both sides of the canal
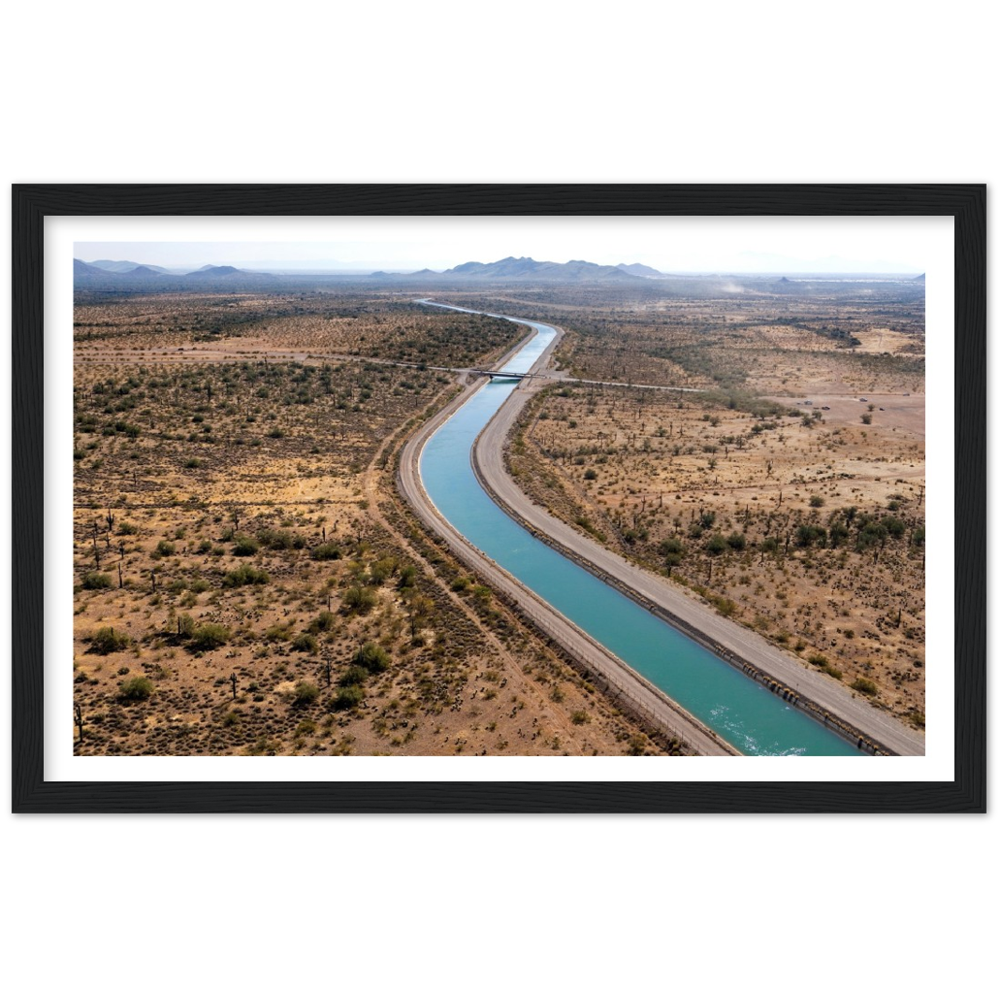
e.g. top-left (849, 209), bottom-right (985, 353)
top-left (67, 282), bottom-right (925, 755)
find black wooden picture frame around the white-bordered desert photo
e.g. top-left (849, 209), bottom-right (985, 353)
top-left (10, 182), bottom-right (987, 812)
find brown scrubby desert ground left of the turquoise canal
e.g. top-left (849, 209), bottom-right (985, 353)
top-left (67, 293), bottom-right (684, 755)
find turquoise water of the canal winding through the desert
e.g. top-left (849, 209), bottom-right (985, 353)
top-left (420, 308), bottom-right (861, 756)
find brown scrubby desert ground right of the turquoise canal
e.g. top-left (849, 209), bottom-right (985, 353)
top-left (478, 286), bottom-right (925, 727)
